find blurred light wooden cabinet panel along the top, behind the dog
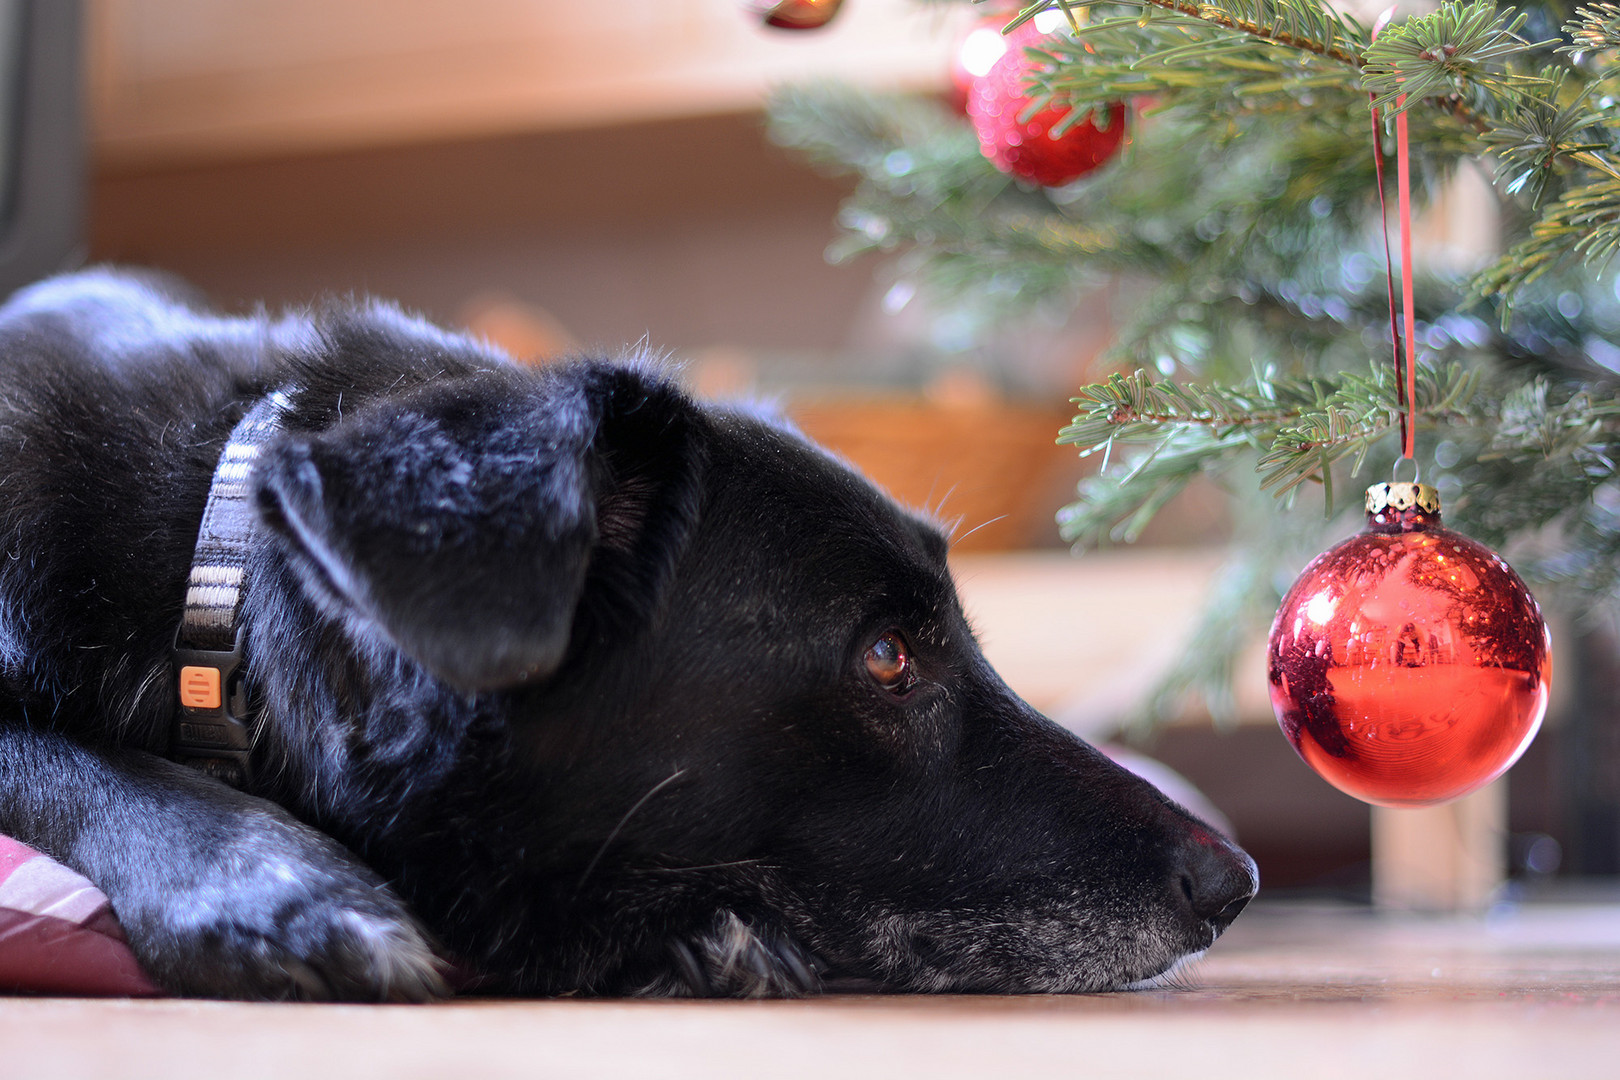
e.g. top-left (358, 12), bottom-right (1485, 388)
top-left (89, 0), bottom-right (972, 165)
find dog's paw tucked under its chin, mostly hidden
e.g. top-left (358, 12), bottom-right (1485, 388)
top-left (642, 912), bottom-right (821, 997)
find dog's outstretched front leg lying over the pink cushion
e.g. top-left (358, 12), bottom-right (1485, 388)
top-left (0, 721), bottom-right (446, 1001)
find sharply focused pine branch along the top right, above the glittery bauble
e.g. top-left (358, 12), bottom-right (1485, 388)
top-left (984, 0), bottom-right (1620, 325)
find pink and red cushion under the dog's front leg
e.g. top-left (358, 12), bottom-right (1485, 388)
top-left (0, 836), bottom-right (162, 997)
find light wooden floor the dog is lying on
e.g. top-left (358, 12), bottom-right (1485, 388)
top-left (0, 904), bottom-right (1620, 1080)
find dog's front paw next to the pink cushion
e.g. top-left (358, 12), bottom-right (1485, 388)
top-left (113, 813), bottom-right (449, 1002)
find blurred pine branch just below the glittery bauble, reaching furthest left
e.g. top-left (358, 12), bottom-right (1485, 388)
top-left (771, 86), bottom-right (1406, 317)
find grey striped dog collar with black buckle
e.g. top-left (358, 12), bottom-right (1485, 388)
top-left (170, 390), bottom-right (292, 787)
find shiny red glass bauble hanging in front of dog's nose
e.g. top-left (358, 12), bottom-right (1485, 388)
top-left (1267, 484), bottom-right (1552, 806)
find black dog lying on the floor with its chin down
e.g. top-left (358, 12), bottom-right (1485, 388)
top-left (0, 270), bottom-right (1256, 999)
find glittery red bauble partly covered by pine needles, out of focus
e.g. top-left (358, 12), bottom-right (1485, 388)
top-left (967, 21), bottom-right (1124, 188)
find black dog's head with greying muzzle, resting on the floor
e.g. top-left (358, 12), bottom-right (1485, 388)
top-left (259, 352), bottom-right (1256, 993)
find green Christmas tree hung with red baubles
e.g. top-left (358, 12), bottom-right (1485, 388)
top-left (771, 0), bottom-right (1620, 735)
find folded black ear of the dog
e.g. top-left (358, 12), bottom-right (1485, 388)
top-left (256, 366), bottom-right (699, 691)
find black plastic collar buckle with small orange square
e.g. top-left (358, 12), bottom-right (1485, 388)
top-left (170, 631), bottom-right (253, 787)
